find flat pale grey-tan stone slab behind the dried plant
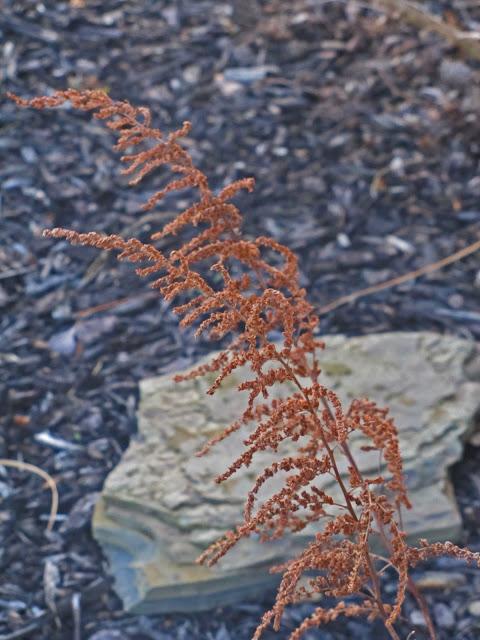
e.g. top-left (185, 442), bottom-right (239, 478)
top-left (93, 332), bottom-right (480, 613)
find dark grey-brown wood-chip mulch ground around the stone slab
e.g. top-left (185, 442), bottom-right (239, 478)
top-left (0, 0), bottom-right (480, 640)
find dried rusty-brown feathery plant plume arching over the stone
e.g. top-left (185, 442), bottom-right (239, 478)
top-left (10, 89), bottom-right (480, 640)
